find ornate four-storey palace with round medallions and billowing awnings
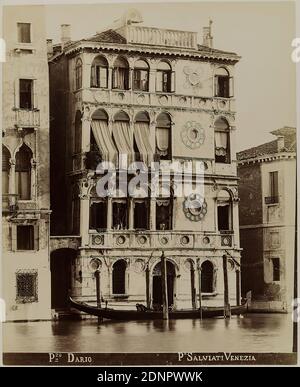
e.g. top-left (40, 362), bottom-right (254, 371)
top-left (48, 11), bottom-right (241, 318)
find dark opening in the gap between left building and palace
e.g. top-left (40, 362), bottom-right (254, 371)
top-left (50, 249), bottom-right (77, 309)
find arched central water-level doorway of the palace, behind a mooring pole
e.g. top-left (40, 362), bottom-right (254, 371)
top-left (152, 261), bottom-right (175, 307)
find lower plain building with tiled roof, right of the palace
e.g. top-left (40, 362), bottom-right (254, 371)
top-left (237, 127), bottom-right (296, 311)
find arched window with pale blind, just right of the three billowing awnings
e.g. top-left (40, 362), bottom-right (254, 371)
top-left (155, 113), bottom-right (172, 160)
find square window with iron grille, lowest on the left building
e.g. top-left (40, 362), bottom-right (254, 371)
top-left (16, 270), bottom-right (38, 303)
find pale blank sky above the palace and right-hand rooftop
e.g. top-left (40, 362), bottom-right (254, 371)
top-left (40, 1), bottom-right (296, 151)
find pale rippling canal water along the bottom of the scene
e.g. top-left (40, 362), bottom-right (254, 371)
top-left (2, 314), bottom-right (293, 353)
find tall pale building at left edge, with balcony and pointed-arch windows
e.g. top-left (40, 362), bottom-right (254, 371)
top-left (2, 6), bottom-right (51, 320)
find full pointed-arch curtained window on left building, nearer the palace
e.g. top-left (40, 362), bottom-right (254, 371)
top-left (15, 144), bottom-right (32, 200)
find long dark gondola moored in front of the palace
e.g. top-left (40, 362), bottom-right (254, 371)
top-left (70, 297), bottom-right (248, 321)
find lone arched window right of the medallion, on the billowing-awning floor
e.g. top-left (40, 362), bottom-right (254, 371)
top-left (214, 117), bottom-right (230, 164)
